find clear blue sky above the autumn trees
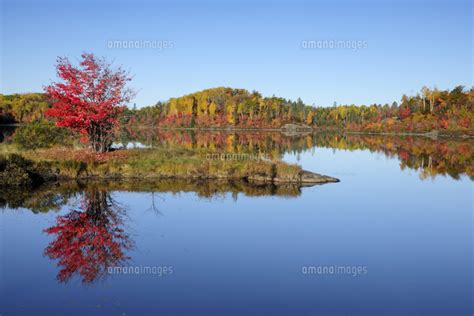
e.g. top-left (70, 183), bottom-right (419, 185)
top-left (0, 0), bottom-right (473, 106)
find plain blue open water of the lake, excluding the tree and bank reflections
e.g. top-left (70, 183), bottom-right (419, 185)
top-left (0, 144), bottom-right (474, 316)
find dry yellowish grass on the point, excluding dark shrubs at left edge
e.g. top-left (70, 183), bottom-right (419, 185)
top-left (1, 146), bottom-right (301, 179)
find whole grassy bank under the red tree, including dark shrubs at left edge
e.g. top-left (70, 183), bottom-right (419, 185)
top-left (0, 145), bottom-right (312, 185)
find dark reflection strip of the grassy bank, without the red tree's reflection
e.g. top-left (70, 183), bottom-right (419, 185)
top-left (0, 179), bottom-right (308, 213)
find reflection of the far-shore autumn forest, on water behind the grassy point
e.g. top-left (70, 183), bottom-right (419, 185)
top-left (119, 129), bottom-right (474, 180)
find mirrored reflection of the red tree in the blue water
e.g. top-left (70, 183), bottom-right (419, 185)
top-left (44, 189), bottom-right (132, 283)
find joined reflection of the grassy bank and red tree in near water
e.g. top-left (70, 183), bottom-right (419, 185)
top-left (0, 180), bottom-right (301, 283)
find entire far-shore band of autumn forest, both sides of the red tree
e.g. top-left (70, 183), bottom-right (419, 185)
top-left (0, 86), bottom-right (474, 132)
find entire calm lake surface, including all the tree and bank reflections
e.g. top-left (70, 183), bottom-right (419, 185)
top-left (0, 131), bottom-right (474, 315)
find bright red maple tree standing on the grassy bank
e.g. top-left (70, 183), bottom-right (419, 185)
top-left (45, 53), bottom-right (135, 152)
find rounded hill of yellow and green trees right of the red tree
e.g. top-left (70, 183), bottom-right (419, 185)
top-left (124, 87), bottom-right (314, 128)
